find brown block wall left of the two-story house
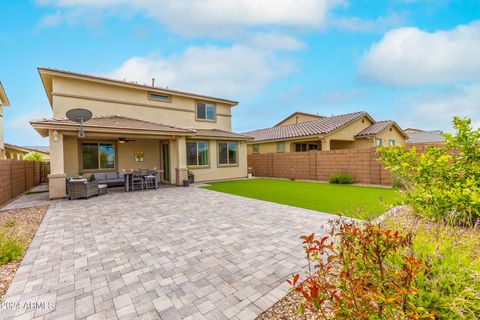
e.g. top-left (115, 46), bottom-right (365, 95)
top-left (0, 160), bottom-right (42, 206)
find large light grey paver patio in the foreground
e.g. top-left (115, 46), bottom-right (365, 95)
top-left (0, 187), bottom-right (333, 320)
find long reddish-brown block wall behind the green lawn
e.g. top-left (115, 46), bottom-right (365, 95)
top-left (248, 144), bottom-right (436, 186)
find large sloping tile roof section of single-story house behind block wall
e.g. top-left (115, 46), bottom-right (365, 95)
top-left (243, 111), bottom-right (373, 142)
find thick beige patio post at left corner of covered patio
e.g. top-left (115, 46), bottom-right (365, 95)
top-left (48, 130), bottom-right (67, 199)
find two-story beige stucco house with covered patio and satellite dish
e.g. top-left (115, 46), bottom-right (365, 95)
top-left (30, 68), bottom-right (251, 198)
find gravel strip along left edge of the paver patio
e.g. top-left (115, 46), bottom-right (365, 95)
top-left (0, 206), bottom-right (48, 301)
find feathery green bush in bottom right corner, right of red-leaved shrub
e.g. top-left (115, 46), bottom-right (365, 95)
top-left (385, 214), bottom-right (480, 319)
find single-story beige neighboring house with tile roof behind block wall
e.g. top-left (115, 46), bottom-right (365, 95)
top-left (244, 112), bottom-right (408, 154)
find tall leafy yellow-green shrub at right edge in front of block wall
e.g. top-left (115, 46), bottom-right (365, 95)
top-left (377, 117), bottom-right (480, 225)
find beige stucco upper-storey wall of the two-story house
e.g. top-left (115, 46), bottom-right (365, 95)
top-left (53, 77), bottom-right (231, 131)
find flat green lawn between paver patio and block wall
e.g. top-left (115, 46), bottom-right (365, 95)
top-left (203, 179), bottom-right (398, 218)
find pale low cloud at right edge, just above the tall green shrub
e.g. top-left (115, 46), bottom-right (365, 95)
top-left (399, 83), bottom-right (480, 131)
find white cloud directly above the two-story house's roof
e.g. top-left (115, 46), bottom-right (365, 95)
top-left (109, 46), bottom-right (296, 97)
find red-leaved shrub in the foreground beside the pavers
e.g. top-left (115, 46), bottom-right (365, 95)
top-left (288, 220), bottom-right (434, 319)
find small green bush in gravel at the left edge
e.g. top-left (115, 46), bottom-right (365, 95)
top-left (0, 220), bottom-right (25, 265)
